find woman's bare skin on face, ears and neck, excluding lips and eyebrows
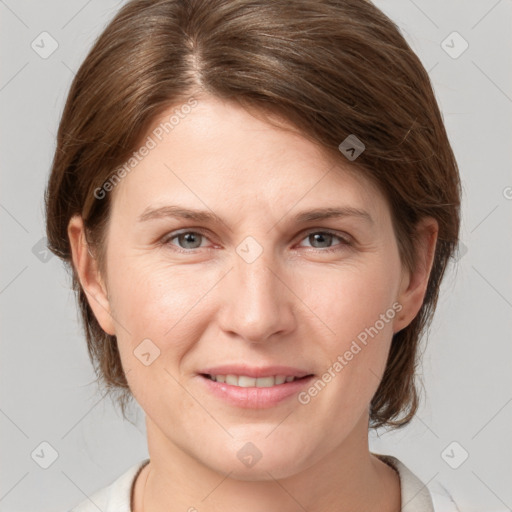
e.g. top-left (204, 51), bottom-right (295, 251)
top-left (68, 96), bottom-right (438, 512)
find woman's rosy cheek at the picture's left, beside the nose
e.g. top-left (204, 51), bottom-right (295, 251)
top-left (109, 257), bottom-right (219, 379)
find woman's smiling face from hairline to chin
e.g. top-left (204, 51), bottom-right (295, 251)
top-left (70, 97), bottom-right (436, 479)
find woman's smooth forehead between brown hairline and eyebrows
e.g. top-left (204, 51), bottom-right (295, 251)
top-left (108, 97), bottom-right (384, 224)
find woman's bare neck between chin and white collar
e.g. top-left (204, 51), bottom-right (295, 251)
top-left (133, 417), bottom-right (401, 512)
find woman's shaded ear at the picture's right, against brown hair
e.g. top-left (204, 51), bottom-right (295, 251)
top-left (393, 217), bottom-right (439, 333)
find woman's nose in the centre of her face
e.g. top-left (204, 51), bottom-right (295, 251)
top-left (219, 249), bottom-right (298, 343)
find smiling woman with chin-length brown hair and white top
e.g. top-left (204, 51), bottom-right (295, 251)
top-left (46, 0), bottom-right (460, 512)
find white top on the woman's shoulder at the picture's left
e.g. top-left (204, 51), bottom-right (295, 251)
top-left (70, 459), bottom-right (149, 512)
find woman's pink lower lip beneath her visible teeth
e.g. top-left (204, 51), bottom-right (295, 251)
top-left (199, 375), bottom-right (313, 409)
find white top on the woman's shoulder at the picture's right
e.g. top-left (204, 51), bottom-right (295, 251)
top-left (373, 453), bottom-right (462, 512)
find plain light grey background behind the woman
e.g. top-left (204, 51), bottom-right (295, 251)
top-left (0, 0), bottom-right (512, 512)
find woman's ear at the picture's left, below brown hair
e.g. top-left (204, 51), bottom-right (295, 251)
top-left (68, 215), bottom-right (115, 335)
